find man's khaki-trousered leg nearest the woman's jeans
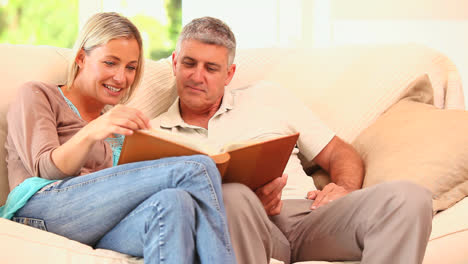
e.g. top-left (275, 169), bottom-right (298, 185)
top-left (222, 183), bottom-right (290, 264)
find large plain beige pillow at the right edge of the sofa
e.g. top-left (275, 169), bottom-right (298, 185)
top-left (353, 98), bottom-right (468, 213)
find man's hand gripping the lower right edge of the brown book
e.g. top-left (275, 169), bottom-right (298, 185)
top-left (255, 174), bottom-right (288, 215)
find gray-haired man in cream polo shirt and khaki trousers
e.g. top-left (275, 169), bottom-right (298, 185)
top-left (151, 17), bottom-right (432, 264)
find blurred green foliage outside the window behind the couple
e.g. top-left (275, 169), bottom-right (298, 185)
top-left (0, 0), bottom-right (182, 59)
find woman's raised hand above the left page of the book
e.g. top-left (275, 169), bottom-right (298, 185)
top-left (80, 105), bottom-right (150, 142)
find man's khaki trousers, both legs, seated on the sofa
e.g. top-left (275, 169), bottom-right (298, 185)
top-left (223, 181), bottom-right (432, 264)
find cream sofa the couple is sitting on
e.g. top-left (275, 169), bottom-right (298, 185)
top-left (0, 44), bottom-right (468, 264)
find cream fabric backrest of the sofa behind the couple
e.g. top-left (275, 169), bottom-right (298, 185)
top-left (0, 44), bottom-right (464, 205)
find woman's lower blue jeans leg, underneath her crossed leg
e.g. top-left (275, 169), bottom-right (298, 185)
top-left (96, 189), bottom-right (198, 264)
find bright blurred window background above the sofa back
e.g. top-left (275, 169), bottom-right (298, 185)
top-left (0, 0), bottom-right (468, 105)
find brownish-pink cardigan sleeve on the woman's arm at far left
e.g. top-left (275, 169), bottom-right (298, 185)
top-left (7, 82), bottom-right (69, 179)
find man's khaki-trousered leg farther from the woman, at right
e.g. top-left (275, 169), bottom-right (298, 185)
top-left (272, 181), bottom-right (432, 264)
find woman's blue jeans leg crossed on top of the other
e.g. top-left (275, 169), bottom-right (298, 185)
top-left (15, 155), bottom-right (234, 263)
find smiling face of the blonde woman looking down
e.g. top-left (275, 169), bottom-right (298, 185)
top-left (75, 38), bottom-right (140, 105)
